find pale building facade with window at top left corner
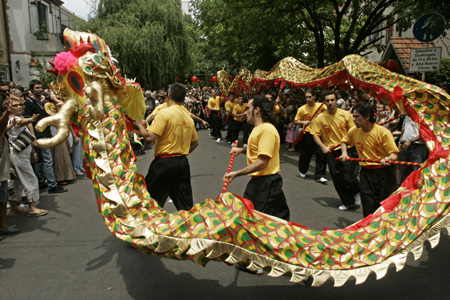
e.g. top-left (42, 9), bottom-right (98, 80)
top-left (0, 0), bottom-right (79, 87)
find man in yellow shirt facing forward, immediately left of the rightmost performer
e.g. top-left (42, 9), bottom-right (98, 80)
top-left (311, 91), bottom-right (360, 210)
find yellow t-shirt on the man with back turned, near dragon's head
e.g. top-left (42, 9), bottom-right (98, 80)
top-left (147, 104), bottom-right (198, 157)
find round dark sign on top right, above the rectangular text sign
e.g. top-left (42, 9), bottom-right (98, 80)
top-left (413, 13), bottom-right (445, 43)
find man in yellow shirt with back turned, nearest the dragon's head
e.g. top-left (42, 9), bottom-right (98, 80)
top-left (133, 83), bottom-right (199, 210)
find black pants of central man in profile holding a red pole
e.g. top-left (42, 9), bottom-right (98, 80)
top-left (244, 174), bottom-right (290, 221)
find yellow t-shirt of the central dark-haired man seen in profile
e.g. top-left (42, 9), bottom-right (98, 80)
top-left (247, 123), bottom-right (280, 176)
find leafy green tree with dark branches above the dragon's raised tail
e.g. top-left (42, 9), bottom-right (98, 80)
top-left (193, 0), bottom-right (418, 68)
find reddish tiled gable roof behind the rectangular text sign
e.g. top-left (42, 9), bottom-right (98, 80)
top-left (381, 37), bottom-right (434, 73)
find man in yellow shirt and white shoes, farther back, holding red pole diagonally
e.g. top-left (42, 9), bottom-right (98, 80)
top-left (294, 89), bottom-right (328, 183)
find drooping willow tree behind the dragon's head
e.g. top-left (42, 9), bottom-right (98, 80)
top-left (84, 0), bottom-right (191, 89)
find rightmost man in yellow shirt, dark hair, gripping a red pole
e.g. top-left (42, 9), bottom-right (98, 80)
top-left (340, 102), bottom-right (400, 217)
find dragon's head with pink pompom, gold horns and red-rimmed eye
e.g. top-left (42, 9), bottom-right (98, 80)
top-left (36, 28), bottom-right (145, 148)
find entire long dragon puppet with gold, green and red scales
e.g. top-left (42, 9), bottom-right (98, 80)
top-left (39, 29), bottom-right (450, 286)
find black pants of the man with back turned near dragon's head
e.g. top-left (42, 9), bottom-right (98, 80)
top-left (145, 156), bottom-right (193, 210)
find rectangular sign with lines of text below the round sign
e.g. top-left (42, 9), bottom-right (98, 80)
top-left (409, 47), bottom-right (442, 72)
